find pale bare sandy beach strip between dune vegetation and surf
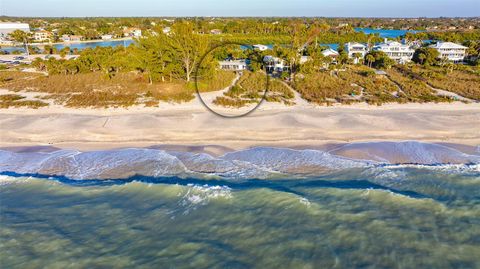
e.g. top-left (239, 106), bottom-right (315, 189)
top-left (0, 94), bottom-right (480, 151)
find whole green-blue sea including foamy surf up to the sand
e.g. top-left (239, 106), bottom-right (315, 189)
top-left (0, 142), bottom-right (480, 268)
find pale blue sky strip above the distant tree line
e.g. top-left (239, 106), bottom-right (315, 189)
top-left (0, 0), bottom-right (480, 17)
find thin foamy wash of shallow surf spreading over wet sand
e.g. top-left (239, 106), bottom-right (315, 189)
top-left (0, 141), bottom-right (480, 180)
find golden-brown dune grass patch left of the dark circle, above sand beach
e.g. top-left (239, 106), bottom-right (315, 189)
top-left (0, 72), bottom-right (194, 107)
